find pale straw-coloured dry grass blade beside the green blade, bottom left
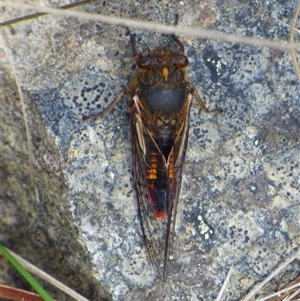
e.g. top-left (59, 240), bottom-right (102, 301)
top-left (9, 250), bottom-right (89, 301)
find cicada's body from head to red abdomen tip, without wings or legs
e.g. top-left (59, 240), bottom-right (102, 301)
top-left (133, 47), bottom-right (190, 218)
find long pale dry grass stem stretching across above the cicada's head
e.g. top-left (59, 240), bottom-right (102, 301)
top-left (3, 2), bottom-right (300, 51)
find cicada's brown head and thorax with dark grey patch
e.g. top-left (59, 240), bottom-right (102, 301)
top-left (134, 47), bottom-right (189, 113)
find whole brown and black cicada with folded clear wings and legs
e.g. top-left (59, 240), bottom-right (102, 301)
top-left (84, 29), bottom-right (221, 279)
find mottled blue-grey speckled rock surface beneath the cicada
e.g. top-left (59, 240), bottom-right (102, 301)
top-left (0, 0), bottom-right (300, 301)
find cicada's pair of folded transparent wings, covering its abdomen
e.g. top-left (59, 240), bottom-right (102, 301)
top-left (131, 95), bottom-right (190, 278)
